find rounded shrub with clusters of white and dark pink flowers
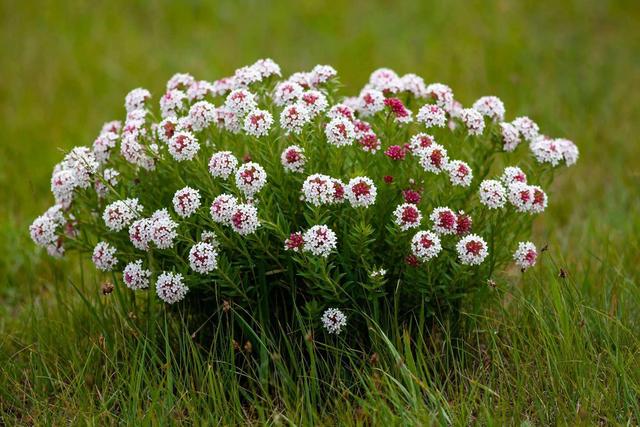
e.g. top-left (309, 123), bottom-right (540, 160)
top-left (30, 59), bottom-right (578, 342)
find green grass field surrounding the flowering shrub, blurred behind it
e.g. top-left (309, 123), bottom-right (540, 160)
top-left (0, 0), bottom-right (640, 425)
